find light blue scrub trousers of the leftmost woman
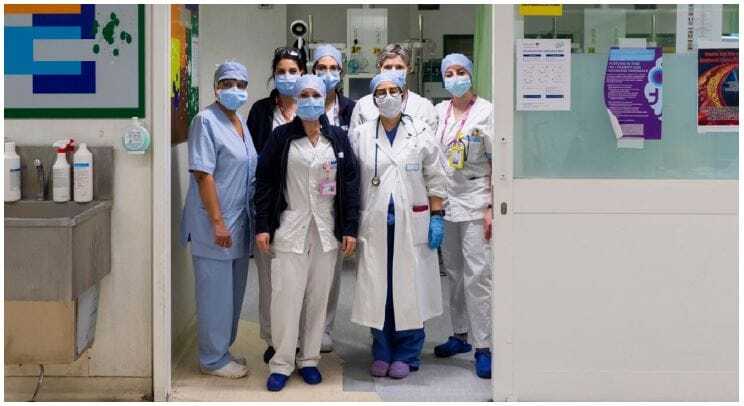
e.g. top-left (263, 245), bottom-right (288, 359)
top-left (192, 256), bottom-right (248, 370)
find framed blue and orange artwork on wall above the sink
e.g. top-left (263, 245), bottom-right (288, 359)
top-left (4, 4), bottom-right (145, 118)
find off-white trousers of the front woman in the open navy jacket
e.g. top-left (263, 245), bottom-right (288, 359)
top-left (269, 222), bottom-right (338, 375)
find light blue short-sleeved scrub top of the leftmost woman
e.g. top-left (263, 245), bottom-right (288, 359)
top-left (181, 103), bottom-right (257, 260)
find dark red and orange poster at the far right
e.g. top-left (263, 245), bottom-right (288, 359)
top-left (697, 48), bottom-right (739, 132)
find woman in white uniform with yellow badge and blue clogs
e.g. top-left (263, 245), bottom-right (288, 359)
top-left (434, 54), bottom-right (493, 378)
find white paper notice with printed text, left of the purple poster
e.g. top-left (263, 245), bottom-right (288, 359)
top-left (517, 39), bottom-right (571, 111)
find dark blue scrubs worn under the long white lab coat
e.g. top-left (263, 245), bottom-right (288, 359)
top-left (371, 126), bottom-right (426, 371)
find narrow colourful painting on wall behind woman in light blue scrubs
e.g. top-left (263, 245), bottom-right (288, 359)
top-left (171, 4), bottom-right (199, 144)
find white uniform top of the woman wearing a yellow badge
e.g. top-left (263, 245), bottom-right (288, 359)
top-left (436, 97), bottom-right (493, 222)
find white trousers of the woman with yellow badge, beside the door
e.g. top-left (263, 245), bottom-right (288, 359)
top-left (442, 220), bottom-right (491, 348)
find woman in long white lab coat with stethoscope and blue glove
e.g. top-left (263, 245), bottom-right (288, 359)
top-left (349, 72), bottom-right (447, 379)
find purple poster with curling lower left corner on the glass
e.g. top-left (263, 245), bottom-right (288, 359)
top-left (604, 47), bottom-right (662, 140)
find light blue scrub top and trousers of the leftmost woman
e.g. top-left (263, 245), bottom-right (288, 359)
top-left (181, 103), bottom-right (257, 370)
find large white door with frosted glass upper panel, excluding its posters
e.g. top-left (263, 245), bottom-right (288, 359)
top-left (493, 5), bottom-right (738, 401)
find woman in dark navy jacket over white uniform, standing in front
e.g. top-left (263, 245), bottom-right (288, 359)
top-left (255, 75), bottom-right (359, 391)
